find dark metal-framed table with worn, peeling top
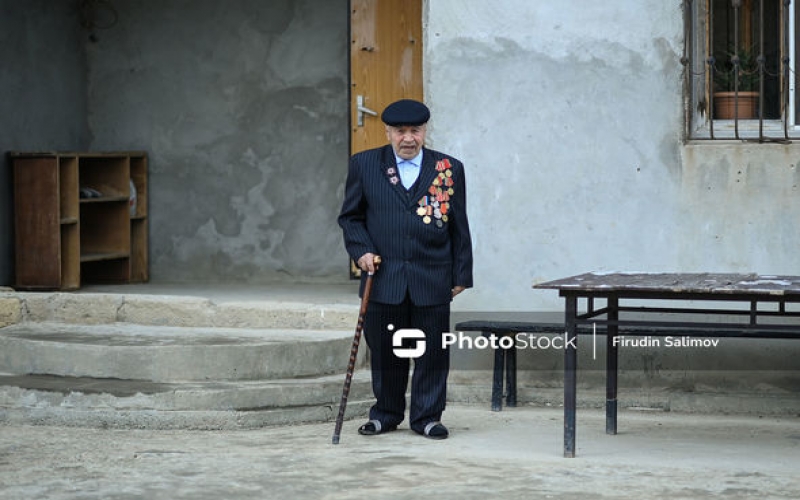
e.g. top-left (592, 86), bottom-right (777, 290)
top-left (534, 273), bottom-right (800, 457)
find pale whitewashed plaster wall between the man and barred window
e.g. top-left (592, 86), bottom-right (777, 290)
top-left (425, 0), bottom-right (800, 310)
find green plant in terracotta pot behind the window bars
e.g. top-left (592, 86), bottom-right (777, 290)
top-left (714, 48), bottom-right (759, 120)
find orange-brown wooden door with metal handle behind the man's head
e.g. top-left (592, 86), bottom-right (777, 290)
top-left (350, 0), bottom-right (423, 153)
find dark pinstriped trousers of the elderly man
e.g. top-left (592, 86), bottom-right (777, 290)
top-left (364, 296), bottom-right (450, 432)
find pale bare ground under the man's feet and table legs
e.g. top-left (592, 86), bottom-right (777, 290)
top-left (0, 405), bottom-right (800, 500)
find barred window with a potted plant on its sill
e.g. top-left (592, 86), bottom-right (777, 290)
top-left (682, 0), bottom-right (800, 142)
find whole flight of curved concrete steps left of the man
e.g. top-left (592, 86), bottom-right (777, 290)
top-left (0, 288), bottom-right (372, 429)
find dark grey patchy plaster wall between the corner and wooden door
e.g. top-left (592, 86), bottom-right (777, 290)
top-left (88, 0), bottom-right (349, 283)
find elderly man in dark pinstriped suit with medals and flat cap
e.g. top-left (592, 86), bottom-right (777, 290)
top-left (339, 99), bottom-right (472, 439)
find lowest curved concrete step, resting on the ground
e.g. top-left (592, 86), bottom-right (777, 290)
top-left (0, 370), bottom-right (372, 429)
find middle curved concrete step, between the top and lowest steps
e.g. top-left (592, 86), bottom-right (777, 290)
top-left (0, 322), bottom-right (366, 383)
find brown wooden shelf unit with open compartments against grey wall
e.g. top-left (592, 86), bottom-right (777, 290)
top-left (9, 151), bottom-right (149, 290)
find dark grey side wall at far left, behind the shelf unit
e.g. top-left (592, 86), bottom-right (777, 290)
top-left (0, 0), bottom-right (88, 286)
